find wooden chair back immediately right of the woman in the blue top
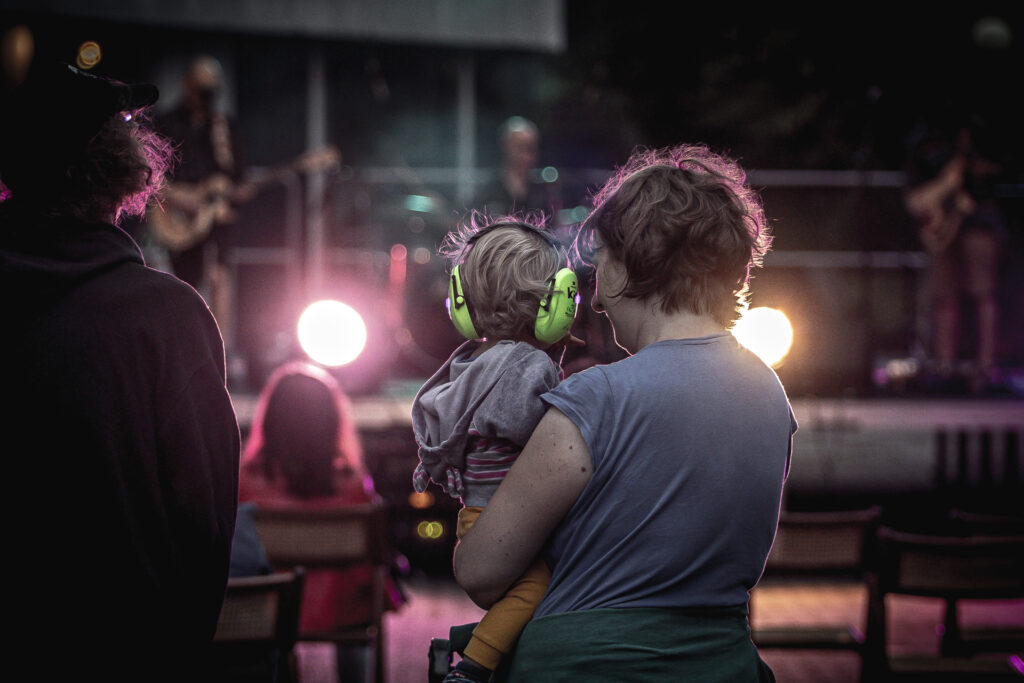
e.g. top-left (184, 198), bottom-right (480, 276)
top-left (765, 507), bottom-right (882, 577)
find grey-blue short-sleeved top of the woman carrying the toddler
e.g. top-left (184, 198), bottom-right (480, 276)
top-left (535, 332), bottom-right (797, 618)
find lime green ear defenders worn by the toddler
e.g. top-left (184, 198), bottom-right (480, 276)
top-left (444, 223), bottom-right (580, 344)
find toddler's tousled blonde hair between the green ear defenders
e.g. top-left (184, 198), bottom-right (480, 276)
top-left (441, 212), bottom-right (568, 341)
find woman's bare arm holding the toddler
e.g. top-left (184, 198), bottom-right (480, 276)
top-left (455, 408), bottom-right (592, 608)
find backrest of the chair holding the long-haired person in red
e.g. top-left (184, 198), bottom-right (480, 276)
top-left (256, 503), bottom-right (391, 569)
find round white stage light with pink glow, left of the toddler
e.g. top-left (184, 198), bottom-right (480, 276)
top-left (298, 300), bottom-right (367, 368)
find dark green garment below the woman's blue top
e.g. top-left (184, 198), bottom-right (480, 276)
top-left (496, 605), bottom-right (775, 683)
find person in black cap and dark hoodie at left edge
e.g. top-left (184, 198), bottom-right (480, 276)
top-left (0, 65), bottom-right (239, 681)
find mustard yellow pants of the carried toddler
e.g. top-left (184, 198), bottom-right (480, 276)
top-left (456, 507), bottom-right (551, 671)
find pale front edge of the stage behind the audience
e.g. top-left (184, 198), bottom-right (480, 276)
top-left (234, 394), bottom-right (1024, 502)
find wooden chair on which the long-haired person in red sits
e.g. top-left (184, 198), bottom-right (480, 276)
top-left (256, 503), bottom-right (392, 683)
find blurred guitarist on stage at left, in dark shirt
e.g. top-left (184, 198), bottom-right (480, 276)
top-left (154, 55), bottom-right (251, 361)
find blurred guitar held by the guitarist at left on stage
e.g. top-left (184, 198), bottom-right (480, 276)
top-left (145, 147), bottom-right (341, 253)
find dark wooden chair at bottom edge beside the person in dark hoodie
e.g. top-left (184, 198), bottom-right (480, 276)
top-left (211, 567), bottom-right (305, 683)
